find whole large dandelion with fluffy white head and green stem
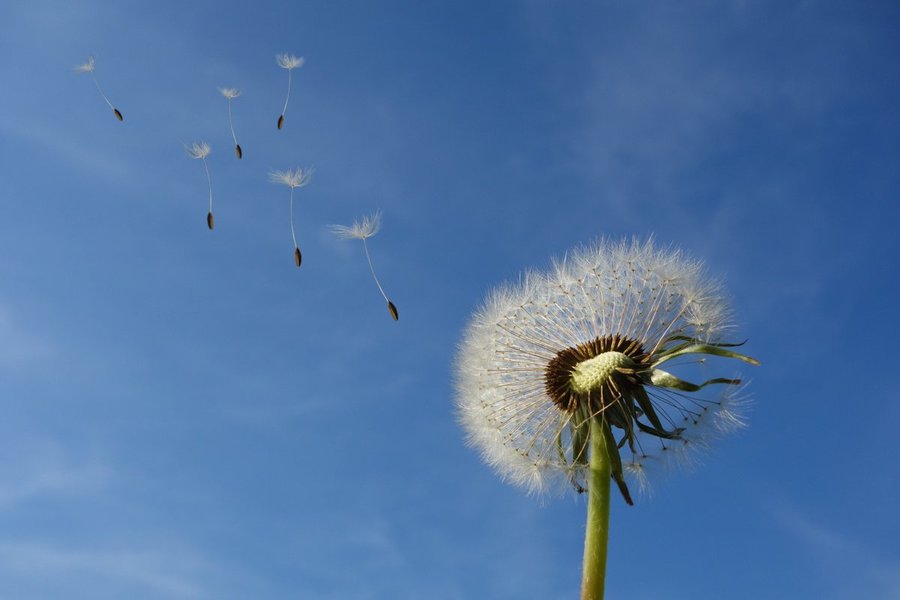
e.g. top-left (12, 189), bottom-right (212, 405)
top-left (456, 241), bottom-right (759, 599)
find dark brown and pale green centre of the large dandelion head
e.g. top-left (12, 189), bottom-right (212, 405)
top-left (544, 335), bottom-right (649, 414)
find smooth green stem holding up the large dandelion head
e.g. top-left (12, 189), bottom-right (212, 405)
top-left (581, 417), bottom-right (610, 600)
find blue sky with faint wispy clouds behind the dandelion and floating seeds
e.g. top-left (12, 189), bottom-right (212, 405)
top-left (0, 1), bottom-right (900, 600)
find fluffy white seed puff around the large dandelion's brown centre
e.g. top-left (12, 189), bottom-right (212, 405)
top-left (456, 241), bottom-right (755, 492)
